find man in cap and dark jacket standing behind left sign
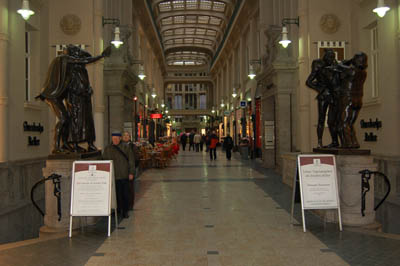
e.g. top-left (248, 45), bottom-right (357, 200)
top-left (103, 132), bottom-right (135, 218)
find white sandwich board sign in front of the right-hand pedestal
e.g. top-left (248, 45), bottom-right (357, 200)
top-left (291, 154), bottom-right (342, 232)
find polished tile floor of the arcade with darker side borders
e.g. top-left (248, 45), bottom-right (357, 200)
top-left (0, 151), bottom-right (400, 266)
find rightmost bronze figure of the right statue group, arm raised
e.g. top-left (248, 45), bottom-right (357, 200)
top-left (337, 53), bottom-right (368, 149)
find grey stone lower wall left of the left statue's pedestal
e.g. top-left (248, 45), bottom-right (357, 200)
top-left (0, 158), bottom-right (45, 244)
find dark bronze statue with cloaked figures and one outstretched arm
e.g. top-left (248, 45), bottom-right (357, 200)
top-left (36, 45), bottom-right (111, 153)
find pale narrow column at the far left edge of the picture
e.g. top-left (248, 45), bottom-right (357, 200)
top-left (0, 0), bottom-right (10, 162)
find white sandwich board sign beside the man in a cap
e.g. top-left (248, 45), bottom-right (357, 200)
top-left (69, 161), bottom-right (118, 237)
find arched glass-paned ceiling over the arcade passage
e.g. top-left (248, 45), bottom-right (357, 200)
top-left (151, 0), bottom-right (237, 66)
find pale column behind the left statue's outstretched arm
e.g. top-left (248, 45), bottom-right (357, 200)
top-left (93, 0), bottom-right (105, 149)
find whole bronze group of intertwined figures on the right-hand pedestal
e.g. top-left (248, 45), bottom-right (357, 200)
top-left (306, 49), bottom-right (368, 149)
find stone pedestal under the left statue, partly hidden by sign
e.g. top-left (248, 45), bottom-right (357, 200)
top-left (40, 152), bottom-right (101, 233)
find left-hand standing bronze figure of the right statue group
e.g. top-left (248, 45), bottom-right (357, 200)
top-left (306, 49), bottom-right (340, 148)
